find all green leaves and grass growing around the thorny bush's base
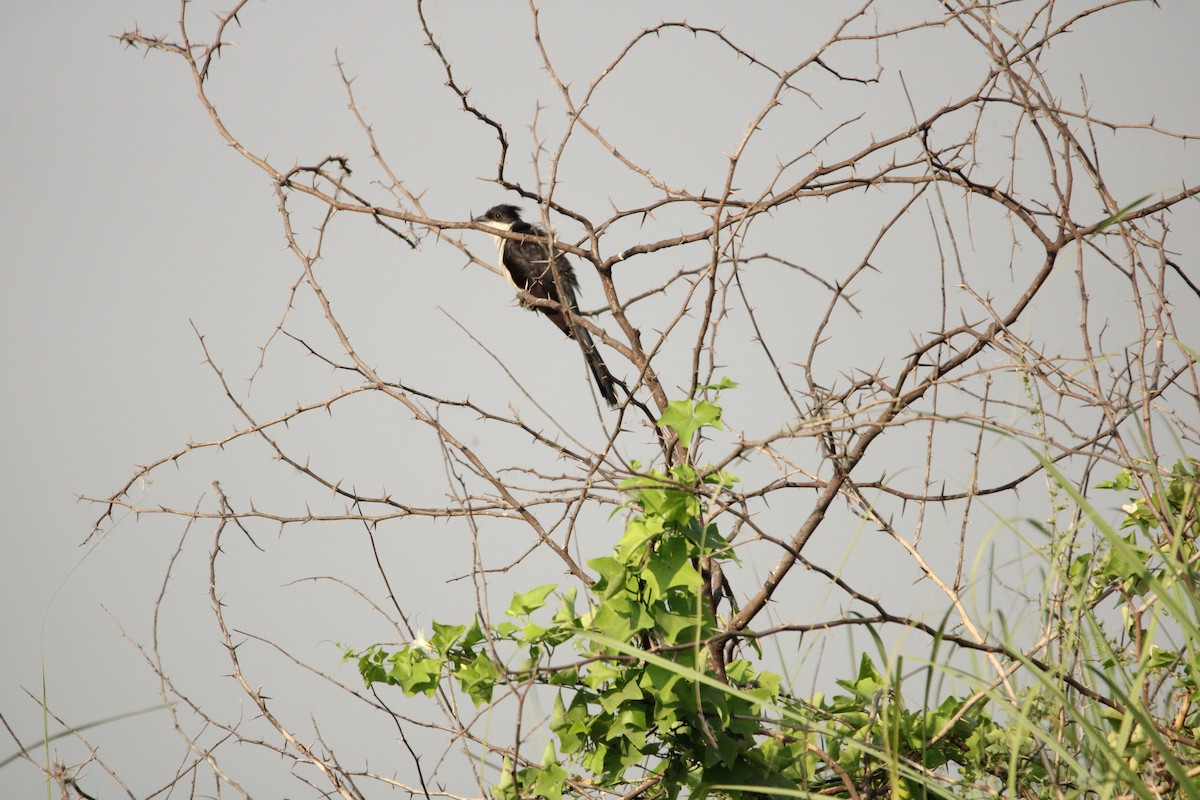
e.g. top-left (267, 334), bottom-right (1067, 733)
top-left (347, 398), bottom-right (1200, 800)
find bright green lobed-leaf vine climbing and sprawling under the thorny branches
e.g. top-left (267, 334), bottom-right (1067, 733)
top-left (346, 398), bottom-right (1196, 800)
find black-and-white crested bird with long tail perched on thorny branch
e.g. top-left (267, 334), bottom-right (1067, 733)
top-left (474, 204), bottom-right (617, 408)
